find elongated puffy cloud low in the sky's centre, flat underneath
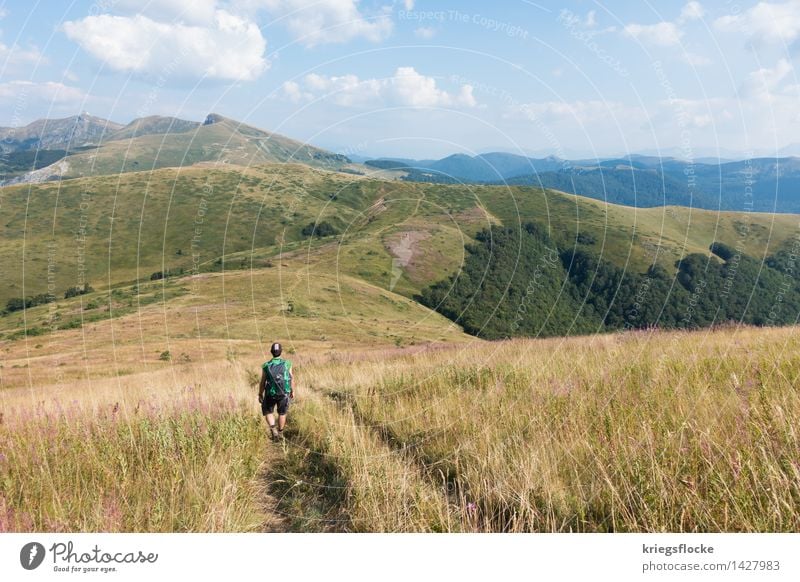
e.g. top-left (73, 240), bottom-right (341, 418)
top-left (282, 67), bottom-right (477, 107)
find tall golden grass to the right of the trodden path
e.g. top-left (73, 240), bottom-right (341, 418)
top-left (296, 330), bottom-right (800, 531)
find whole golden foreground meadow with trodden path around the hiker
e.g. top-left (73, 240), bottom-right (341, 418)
top-left (0, 327), bottom-right (800, 532)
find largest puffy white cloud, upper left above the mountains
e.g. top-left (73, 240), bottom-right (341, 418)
top-left (63, 10), bottom-right (269, 81)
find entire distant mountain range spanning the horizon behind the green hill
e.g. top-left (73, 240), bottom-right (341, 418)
top-left (0, 113), bottom-right (800, 213)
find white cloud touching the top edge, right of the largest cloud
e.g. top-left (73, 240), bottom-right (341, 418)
top-left (261, 0), bottom-right (392, 47)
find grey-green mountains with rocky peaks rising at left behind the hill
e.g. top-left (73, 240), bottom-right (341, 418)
top-left (0, 113), bottom-right (350, 185)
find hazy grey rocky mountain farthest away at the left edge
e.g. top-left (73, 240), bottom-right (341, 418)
top-left (0, 113), bottom-right (123, 153)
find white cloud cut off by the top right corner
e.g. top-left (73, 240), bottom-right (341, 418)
top-left (714, 0), bottom-right (800, 44)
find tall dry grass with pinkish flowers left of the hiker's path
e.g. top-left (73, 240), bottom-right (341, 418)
top-left (0, 368), bottom-right (269, 532)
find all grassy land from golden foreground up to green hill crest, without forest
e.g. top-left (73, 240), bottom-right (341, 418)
top-left (0, 164), bottom-right (800, 531)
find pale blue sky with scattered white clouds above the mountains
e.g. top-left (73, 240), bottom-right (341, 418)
top-left (0, 0), bottom-right (800, 159)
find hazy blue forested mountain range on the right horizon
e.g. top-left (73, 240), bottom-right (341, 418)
top-left (364, 152), bottom-right (800, 212)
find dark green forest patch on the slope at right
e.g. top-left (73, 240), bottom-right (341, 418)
top-left (418, 224), bottom-right (800, 339)
